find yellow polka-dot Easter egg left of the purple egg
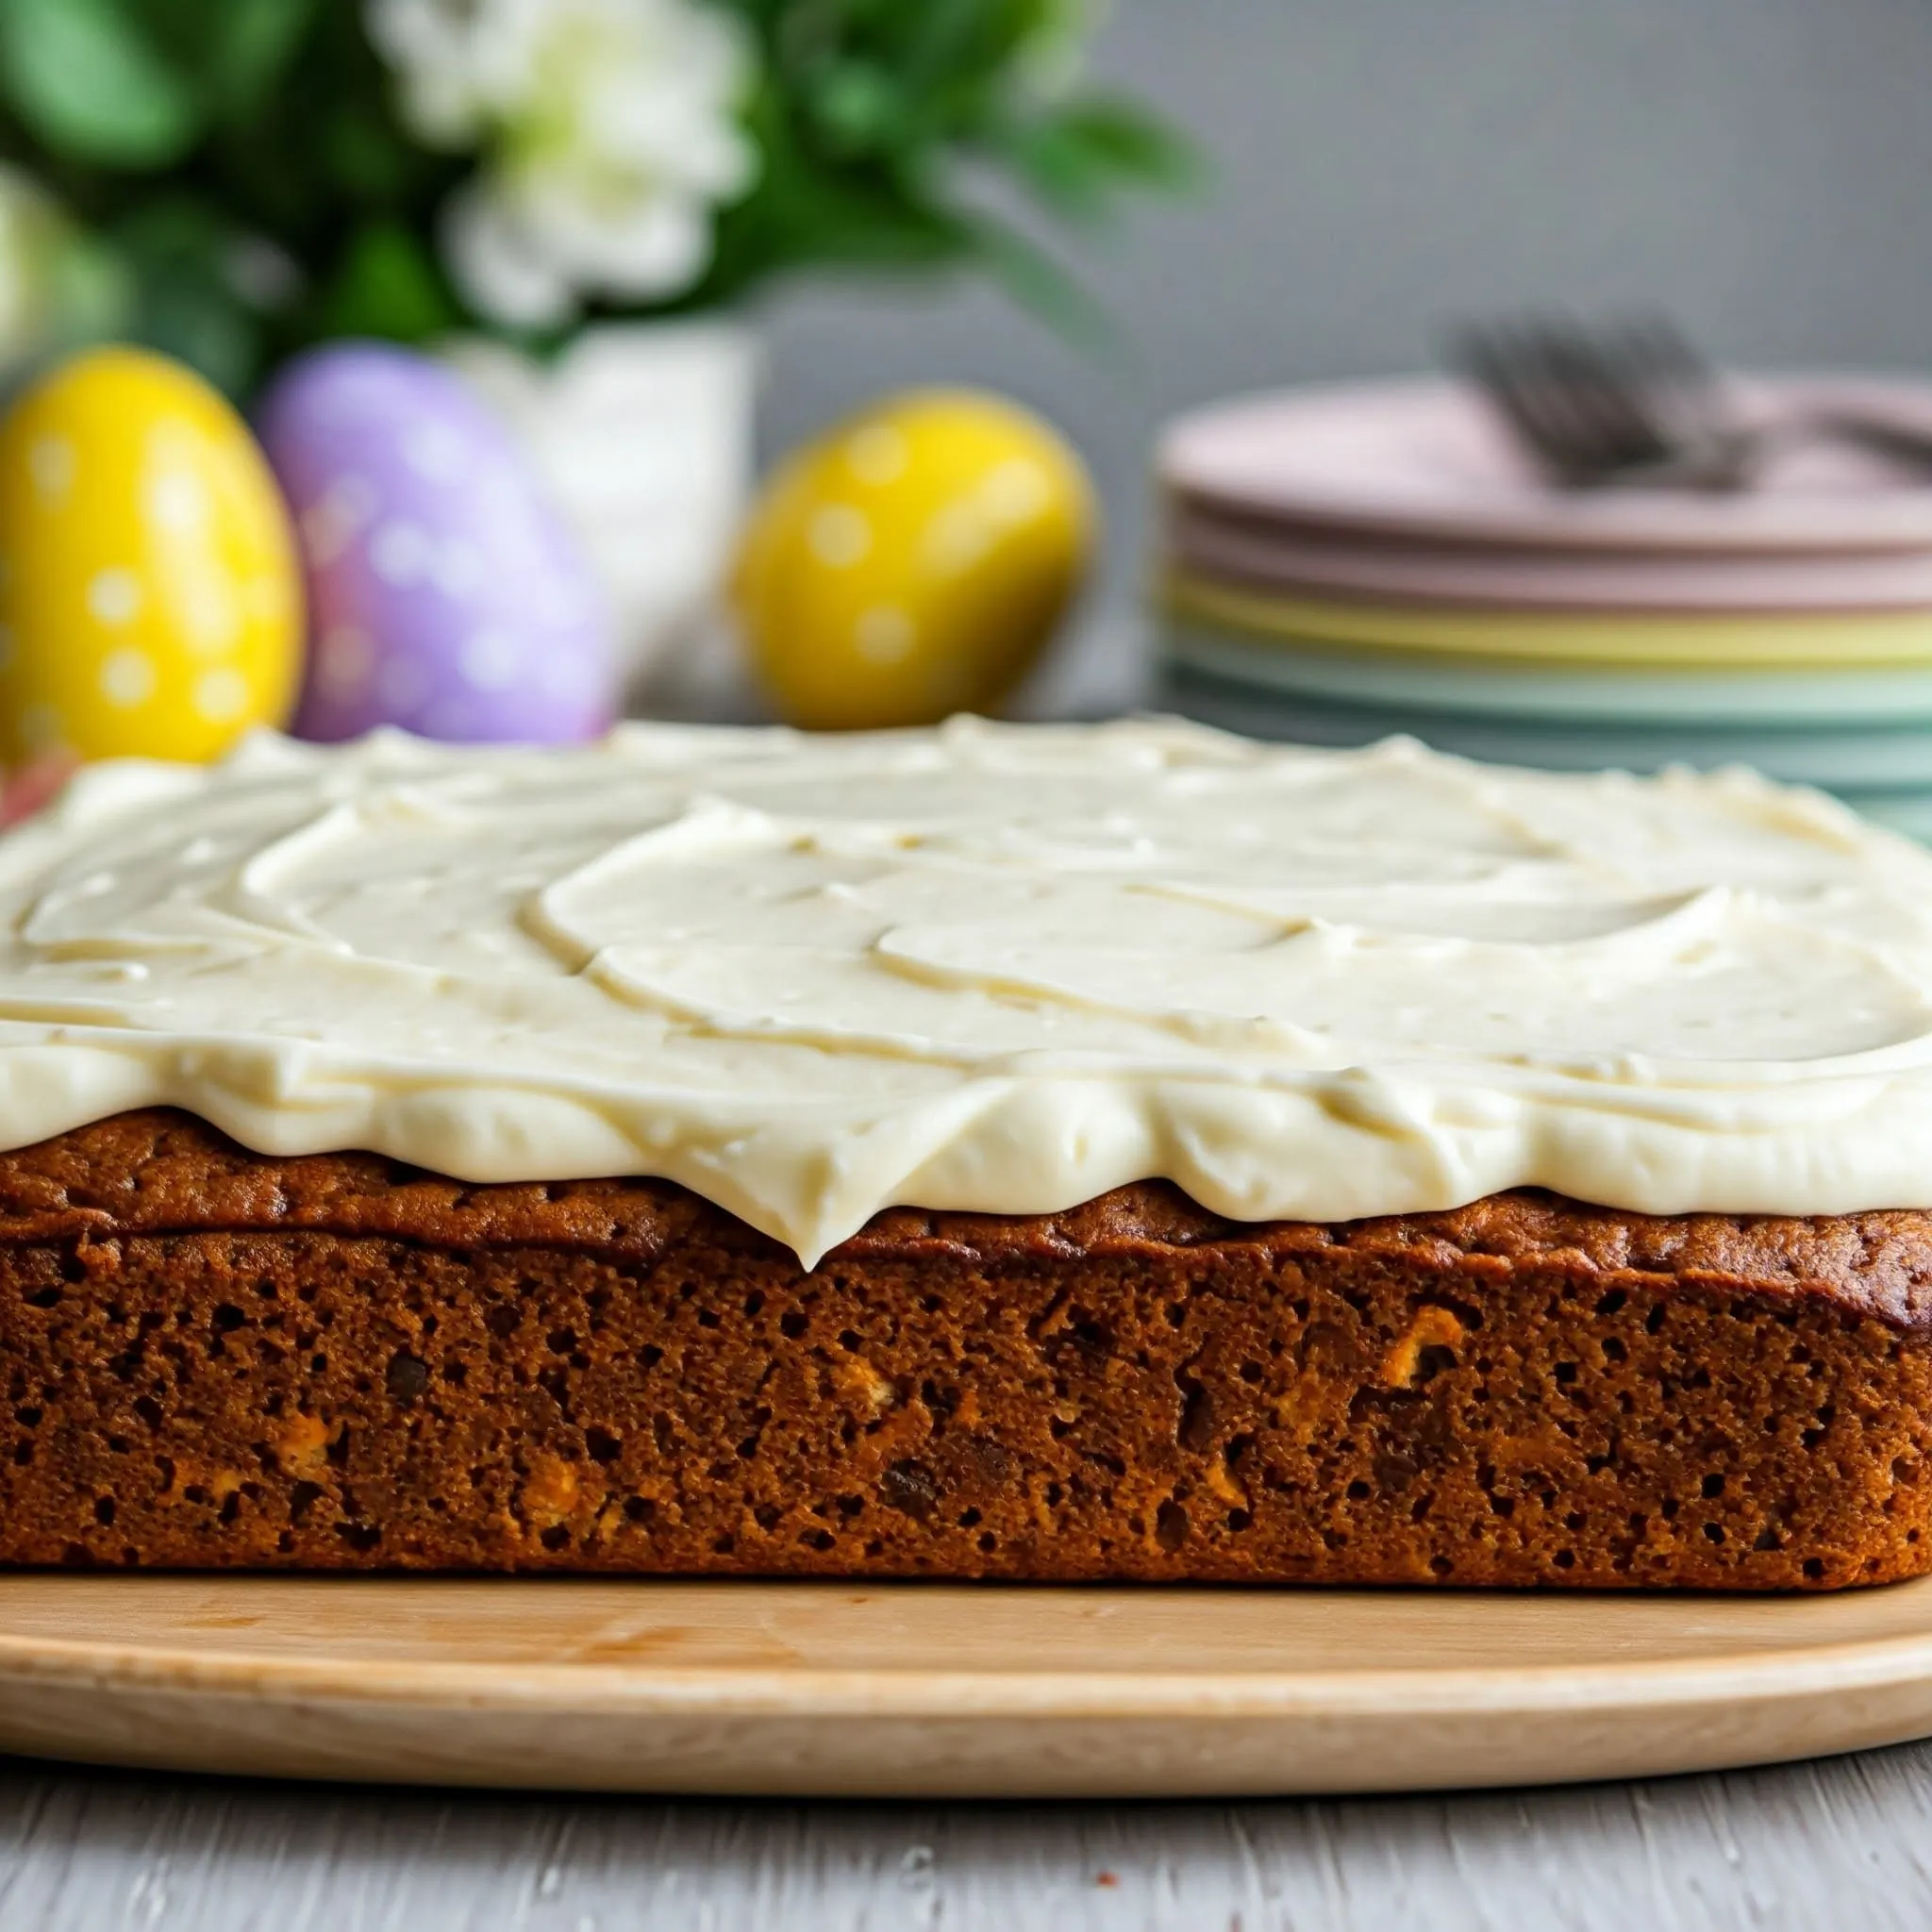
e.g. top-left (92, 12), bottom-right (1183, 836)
top-left (0, 348), bottom-right (301, 765)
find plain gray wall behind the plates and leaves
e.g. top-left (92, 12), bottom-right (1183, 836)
top-left (765, 0), bottom-right (1932, 710)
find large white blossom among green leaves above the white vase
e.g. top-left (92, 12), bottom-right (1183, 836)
top-left (369, 0), bottom-right (756, 328)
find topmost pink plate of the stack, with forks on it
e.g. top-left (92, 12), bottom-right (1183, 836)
top-left (1158, 376), bottom-right (1932, 555)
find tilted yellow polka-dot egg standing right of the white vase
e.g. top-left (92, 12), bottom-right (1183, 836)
top-left (734, 392), bottom-right (1093, 730)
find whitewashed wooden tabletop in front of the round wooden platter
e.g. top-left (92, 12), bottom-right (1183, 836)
top-left (0, 1746), bottom-right (1932, 1932)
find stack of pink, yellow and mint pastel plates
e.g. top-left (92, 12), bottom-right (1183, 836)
top-left (1159, 378), bottom-right (1932, 837)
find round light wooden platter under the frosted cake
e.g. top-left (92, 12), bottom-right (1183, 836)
top-left (0, 1573), bottom-right (1932, 1797)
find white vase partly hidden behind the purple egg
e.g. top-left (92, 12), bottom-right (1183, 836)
top-left (446, 321), bottom-right (759, 693)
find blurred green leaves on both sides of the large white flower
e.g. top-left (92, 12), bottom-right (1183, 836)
top-left (0, 0), bottom-right (1194, 394)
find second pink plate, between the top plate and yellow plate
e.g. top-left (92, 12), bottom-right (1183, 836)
top-left (1165, 498), bottom-right (1932, 614)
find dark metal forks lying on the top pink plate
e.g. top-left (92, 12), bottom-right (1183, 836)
top-left (1449, 315), bottom-right (1932, 491)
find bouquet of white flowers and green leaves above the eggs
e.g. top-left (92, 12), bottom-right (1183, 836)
top-left (0, 0), bottom-right (1189, 394)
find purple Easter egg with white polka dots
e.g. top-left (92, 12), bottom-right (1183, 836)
top-left (258, 341), bottom-right (616, 743)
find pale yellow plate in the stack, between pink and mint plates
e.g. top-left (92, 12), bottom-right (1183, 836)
top-left (1165, 574), bottom-right (1932, 671)
